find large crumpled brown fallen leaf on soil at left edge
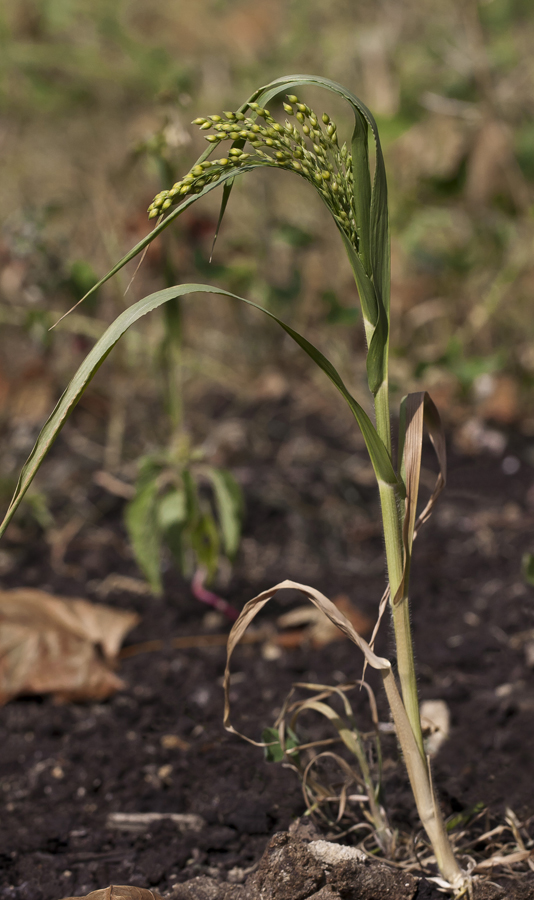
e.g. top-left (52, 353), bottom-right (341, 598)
top-left (0, 588), bottom-right (139, 705)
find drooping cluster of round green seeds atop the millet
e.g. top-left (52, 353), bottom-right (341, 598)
top-left (148, 94), bottom-right (358, 246)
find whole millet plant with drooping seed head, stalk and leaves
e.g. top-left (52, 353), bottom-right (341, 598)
top-left (0, 75), bottom-right (478, 894)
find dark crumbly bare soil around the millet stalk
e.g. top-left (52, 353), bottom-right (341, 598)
top-left (0, 394), bottom-right (534, 900)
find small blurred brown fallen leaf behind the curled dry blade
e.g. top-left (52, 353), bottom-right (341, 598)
top-left (274, 594), bottom-right (373, 649)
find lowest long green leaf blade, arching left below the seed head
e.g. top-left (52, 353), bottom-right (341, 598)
top-left (0, 284), bottom-right (402, 536)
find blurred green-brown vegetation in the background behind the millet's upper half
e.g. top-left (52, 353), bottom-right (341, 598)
top-left (0, 0), bottom-right (534, 576)
